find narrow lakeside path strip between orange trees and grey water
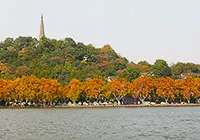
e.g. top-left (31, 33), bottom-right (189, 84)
top-left (0, 104), bottom-right (200, 109)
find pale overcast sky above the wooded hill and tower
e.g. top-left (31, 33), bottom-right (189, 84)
top-left (0, 0), bottom-right (200, 64)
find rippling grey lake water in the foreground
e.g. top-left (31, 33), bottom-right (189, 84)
top-left (0, 107), bottom-right (200, 140)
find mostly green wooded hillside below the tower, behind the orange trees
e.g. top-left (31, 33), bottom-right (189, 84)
top-left (0, 37), bottom-right (200, 85)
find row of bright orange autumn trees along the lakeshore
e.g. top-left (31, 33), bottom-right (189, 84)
top-left (0, 75), bottom-right (200, 105)
